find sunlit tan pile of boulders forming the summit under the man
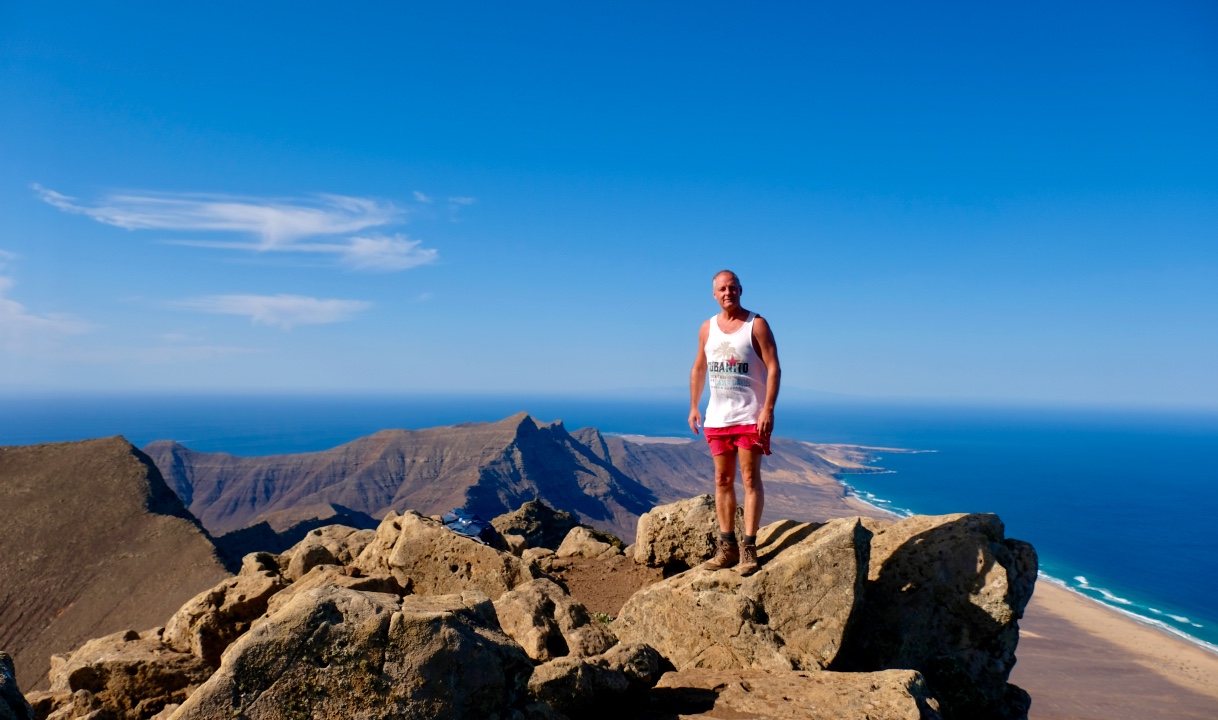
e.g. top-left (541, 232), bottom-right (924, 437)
top-left (9, 497), bottom-right (1037, 720)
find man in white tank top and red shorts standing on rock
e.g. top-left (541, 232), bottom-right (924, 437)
top-left (689, 270), bottom-right (782, 575)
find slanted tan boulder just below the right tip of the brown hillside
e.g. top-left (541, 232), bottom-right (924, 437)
top-left (163, 553), bottom-right (289, 668)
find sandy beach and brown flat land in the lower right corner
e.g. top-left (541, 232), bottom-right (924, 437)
top-left (1011, 580), bottom-right (1218, 720)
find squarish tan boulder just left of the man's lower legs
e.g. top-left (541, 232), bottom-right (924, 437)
top-left (633, 495), bottom-right (744, 569)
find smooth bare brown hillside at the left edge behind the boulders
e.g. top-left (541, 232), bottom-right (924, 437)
top-left (0, 437), bottom-right (228, 688)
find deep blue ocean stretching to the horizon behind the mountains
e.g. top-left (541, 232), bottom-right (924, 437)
top-left (0, 396), bottom-right (1218, 652)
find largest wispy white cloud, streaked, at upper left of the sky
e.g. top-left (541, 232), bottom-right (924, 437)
top-left (33, 184), bottom-right (438, 272)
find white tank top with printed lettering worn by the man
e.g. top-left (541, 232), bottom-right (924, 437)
top-left (703, 313), bottom-right (769, 428)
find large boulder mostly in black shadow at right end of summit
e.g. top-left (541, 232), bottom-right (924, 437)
top-left (843, 514), bottom-right (1037, 719)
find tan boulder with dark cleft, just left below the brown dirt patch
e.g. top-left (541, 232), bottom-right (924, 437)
top-left (495, 577), bottom-right (618, 663)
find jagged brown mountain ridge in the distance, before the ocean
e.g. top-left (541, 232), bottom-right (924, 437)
top-left (145, 412), bottom-right (891, 537)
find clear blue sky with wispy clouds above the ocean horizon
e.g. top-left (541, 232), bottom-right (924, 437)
top-left (0, 0), bottom-right (1218, 408)
